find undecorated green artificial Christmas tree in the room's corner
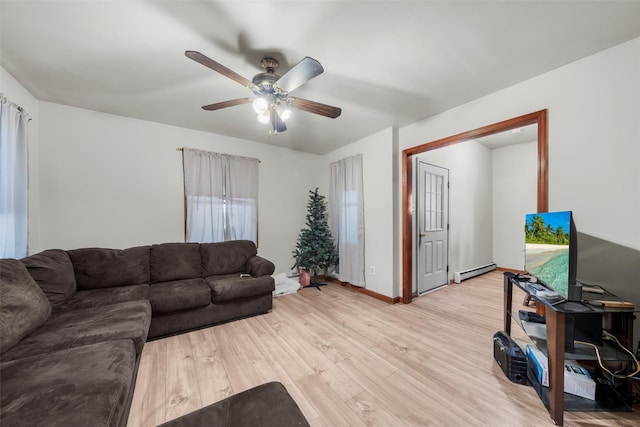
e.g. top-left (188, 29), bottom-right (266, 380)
top-left (293, 188), bottom-right (338, 289)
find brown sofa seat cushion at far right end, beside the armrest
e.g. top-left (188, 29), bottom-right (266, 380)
top-left (206, 274), bottom-right (276, 303)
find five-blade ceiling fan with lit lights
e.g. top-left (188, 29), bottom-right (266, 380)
top-left (184, 50), bottom-right (342, 135)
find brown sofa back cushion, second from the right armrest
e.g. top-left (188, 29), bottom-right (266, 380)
top-left (149, 243), bottom-right (202, 283)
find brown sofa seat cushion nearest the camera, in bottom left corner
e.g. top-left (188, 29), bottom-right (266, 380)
top-left (0, 340), bottom-right (136, 427)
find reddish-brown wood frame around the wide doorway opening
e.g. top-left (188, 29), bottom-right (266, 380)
top-left (402, 109), bottom-right (549, 304)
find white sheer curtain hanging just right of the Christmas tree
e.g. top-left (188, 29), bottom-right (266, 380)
top-left (329, 154), bottom-right (365, 286)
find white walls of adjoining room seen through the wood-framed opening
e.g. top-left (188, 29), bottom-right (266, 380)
top-left (404, 140), bottom-right (538, 279)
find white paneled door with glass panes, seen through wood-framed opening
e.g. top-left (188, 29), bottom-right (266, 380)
top-left (416, 159), bottom-right (449, 294)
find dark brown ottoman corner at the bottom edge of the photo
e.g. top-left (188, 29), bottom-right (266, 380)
top-left (160, 381), bottom-right (309, 427)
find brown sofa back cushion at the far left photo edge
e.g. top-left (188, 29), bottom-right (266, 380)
top-left (0, 259), bottom-right (51, 353)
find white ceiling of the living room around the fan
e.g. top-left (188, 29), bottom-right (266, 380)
top-left (0, 0), bottom-right (640, 154)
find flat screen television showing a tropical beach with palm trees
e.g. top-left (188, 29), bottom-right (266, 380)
top-left (524, 211), bottom-right (582, 301)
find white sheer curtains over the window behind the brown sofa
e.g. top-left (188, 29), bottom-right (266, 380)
top-left (182, 148), bottom-right (259, 244)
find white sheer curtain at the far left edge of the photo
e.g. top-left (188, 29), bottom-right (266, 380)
top-left (0, 95), bottom-right (29, 258)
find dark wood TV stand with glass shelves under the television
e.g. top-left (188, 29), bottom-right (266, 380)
top-left (504, 272), bottom-right (634, 425)
